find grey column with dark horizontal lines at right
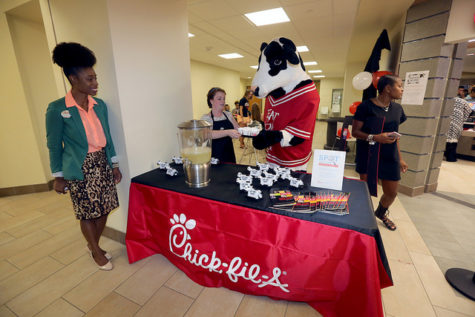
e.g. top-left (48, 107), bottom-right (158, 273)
top-left (399, 0), bottom-right (464, 196)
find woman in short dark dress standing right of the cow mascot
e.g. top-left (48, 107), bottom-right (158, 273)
top-left (352, 75), bottom-right (407, 230)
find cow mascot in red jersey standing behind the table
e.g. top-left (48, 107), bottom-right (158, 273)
top-left (252, 37), bottom-right (320, 170)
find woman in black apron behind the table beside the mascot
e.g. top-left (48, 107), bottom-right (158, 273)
top-left (201, 87), bottom-right (241, 163)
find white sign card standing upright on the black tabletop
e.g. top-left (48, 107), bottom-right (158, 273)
top-left (311, 150), bottom-right (346, 190)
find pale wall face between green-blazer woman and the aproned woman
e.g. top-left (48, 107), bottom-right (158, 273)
top-left (107, 0), bottom-right (193, 232)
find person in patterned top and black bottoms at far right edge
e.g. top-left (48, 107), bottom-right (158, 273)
top-left (444, 97), bottom-right (472, 162)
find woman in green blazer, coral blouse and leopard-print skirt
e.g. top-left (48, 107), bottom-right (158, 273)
top-left (46, 43), bottom-right (122, 271)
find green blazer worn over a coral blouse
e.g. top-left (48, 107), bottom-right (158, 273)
top-left (46, 97), bottom-right (116, 180)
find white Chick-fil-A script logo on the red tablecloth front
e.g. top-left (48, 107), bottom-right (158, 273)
top-left (168, 214), bottom-right (289, 292)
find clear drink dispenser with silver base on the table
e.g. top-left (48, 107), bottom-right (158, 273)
top-left (178, 120), bottom-right (212, 188)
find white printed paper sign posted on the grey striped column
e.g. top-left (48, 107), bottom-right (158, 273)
top-left (401, 70), bottom-right (429, 105)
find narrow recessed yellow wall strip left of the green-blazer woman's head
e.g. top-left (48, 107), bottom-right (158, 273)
top-left (8, 6), bottom-right (57, 183)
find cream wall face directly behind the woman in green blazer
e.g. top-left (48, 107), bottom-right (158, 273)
top-left (45, 0), bottom-right (130, 232)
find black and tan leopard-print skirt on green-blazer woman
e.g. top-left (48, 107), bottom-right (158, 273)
top-left (68, 149), bottom-right (119, 220)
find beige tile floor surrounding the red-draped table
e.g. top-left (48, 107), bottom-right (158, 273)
top-left (0, 124), bottom-right (475, 317)
